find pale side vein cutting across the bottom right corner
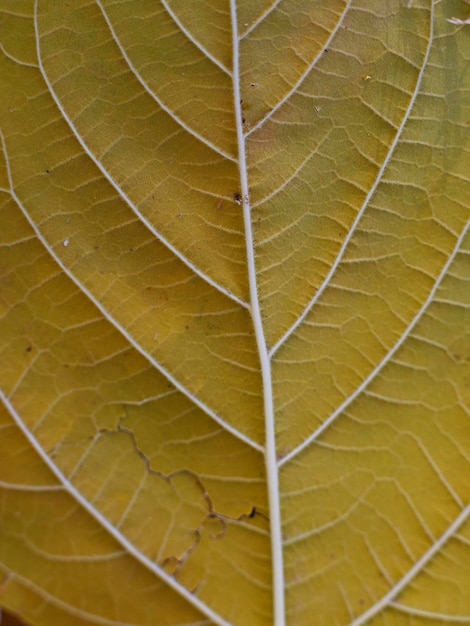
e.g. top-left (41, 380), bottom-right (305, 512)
top-left (349, 506), bottom-right (470, 626)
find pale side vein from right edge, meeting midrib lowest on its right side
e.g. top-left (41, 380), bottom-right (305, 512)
top-left (279, 217), bottom-right (470, 466)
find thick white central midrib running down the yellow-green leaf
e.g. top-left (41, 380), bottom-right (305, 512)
top-left (230, 0), bottom-right (286, 626)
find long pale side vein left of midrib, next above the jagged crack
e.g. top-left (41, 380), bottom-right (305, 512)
top-left (0, 130), bottom-right (263, 452)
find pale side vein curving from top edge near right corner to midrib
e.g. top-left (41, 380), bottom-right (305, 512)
top-left (270, 4), bottom-right (434, 357)
